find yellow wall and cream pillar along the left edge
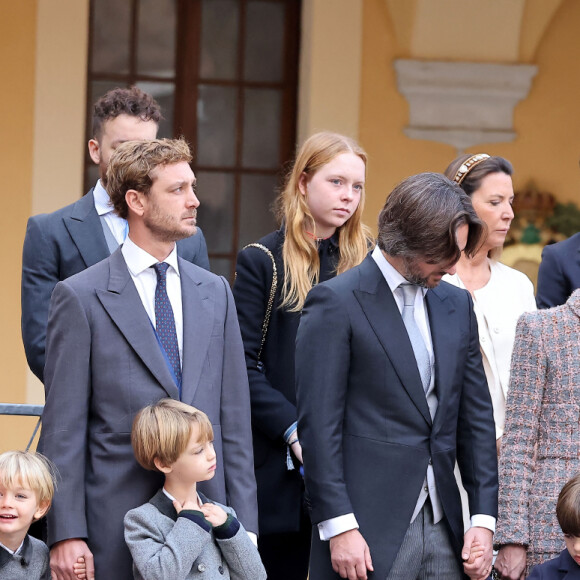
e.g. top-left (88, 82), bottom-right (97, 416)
top-left (0, 0), bottom-right (89, 451)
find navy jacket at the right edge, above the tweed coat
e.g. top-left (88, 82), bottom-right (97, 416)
top-left (536, 233), bottom-right (580, 308)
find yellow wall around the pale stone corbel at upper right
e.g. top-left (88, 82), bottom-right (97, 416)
top-left (359, 0), bottom-right (580, 227)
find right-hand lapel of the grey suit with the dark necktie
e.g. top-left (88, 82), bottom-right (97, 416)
top-left (179, 258), bottom-right (215, 404)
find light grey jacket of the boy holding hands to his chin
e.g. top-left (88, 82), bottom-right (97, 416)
top-left (125, 490), bottom-right (266, 580)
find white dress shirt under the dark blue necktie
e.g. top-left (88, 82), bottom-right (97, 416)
top-left (121, 234), bottom-right (183, 367)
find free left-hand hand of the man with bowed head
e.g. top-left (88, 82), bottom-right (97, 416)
top-left (330, 530), bottom-right (374, 580)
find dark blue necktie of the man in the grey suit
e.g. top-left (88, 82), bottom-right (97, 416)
top-left (153, 262), bottom-right (181, 395)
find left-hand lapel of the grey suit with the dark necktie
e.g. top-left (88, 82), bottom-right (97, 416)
top-left (97, 249), bottom-right (179, 399)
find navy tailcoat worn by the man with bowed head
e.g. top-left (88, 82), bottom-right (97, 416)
top-left (296, 256), bottom-right (498, 580)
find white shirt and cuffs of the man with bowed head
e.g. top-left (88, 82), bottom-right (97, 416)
top-left (318, 246), bottom-right (495, 541)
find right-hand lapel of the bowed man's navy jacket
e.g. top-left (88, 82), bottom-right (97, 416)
top-left (425, 286), bottom-right (458, 424)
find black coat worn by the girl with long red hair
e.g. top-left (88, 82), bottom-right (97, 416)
top-left (233, 230), bottom-right (339, 534)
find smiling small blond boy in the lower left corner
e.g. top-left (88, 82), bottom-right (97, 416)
top-left (0, 451), bottom-right (55, 580)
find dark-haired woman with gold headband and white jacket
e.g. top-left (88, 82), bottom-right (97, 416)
top-left (443, 153), bottom-right (536, 455)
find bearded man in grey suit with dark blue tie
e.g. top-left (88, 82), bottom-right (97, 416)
top-left (39, 139), bottom-right (257, 580)
